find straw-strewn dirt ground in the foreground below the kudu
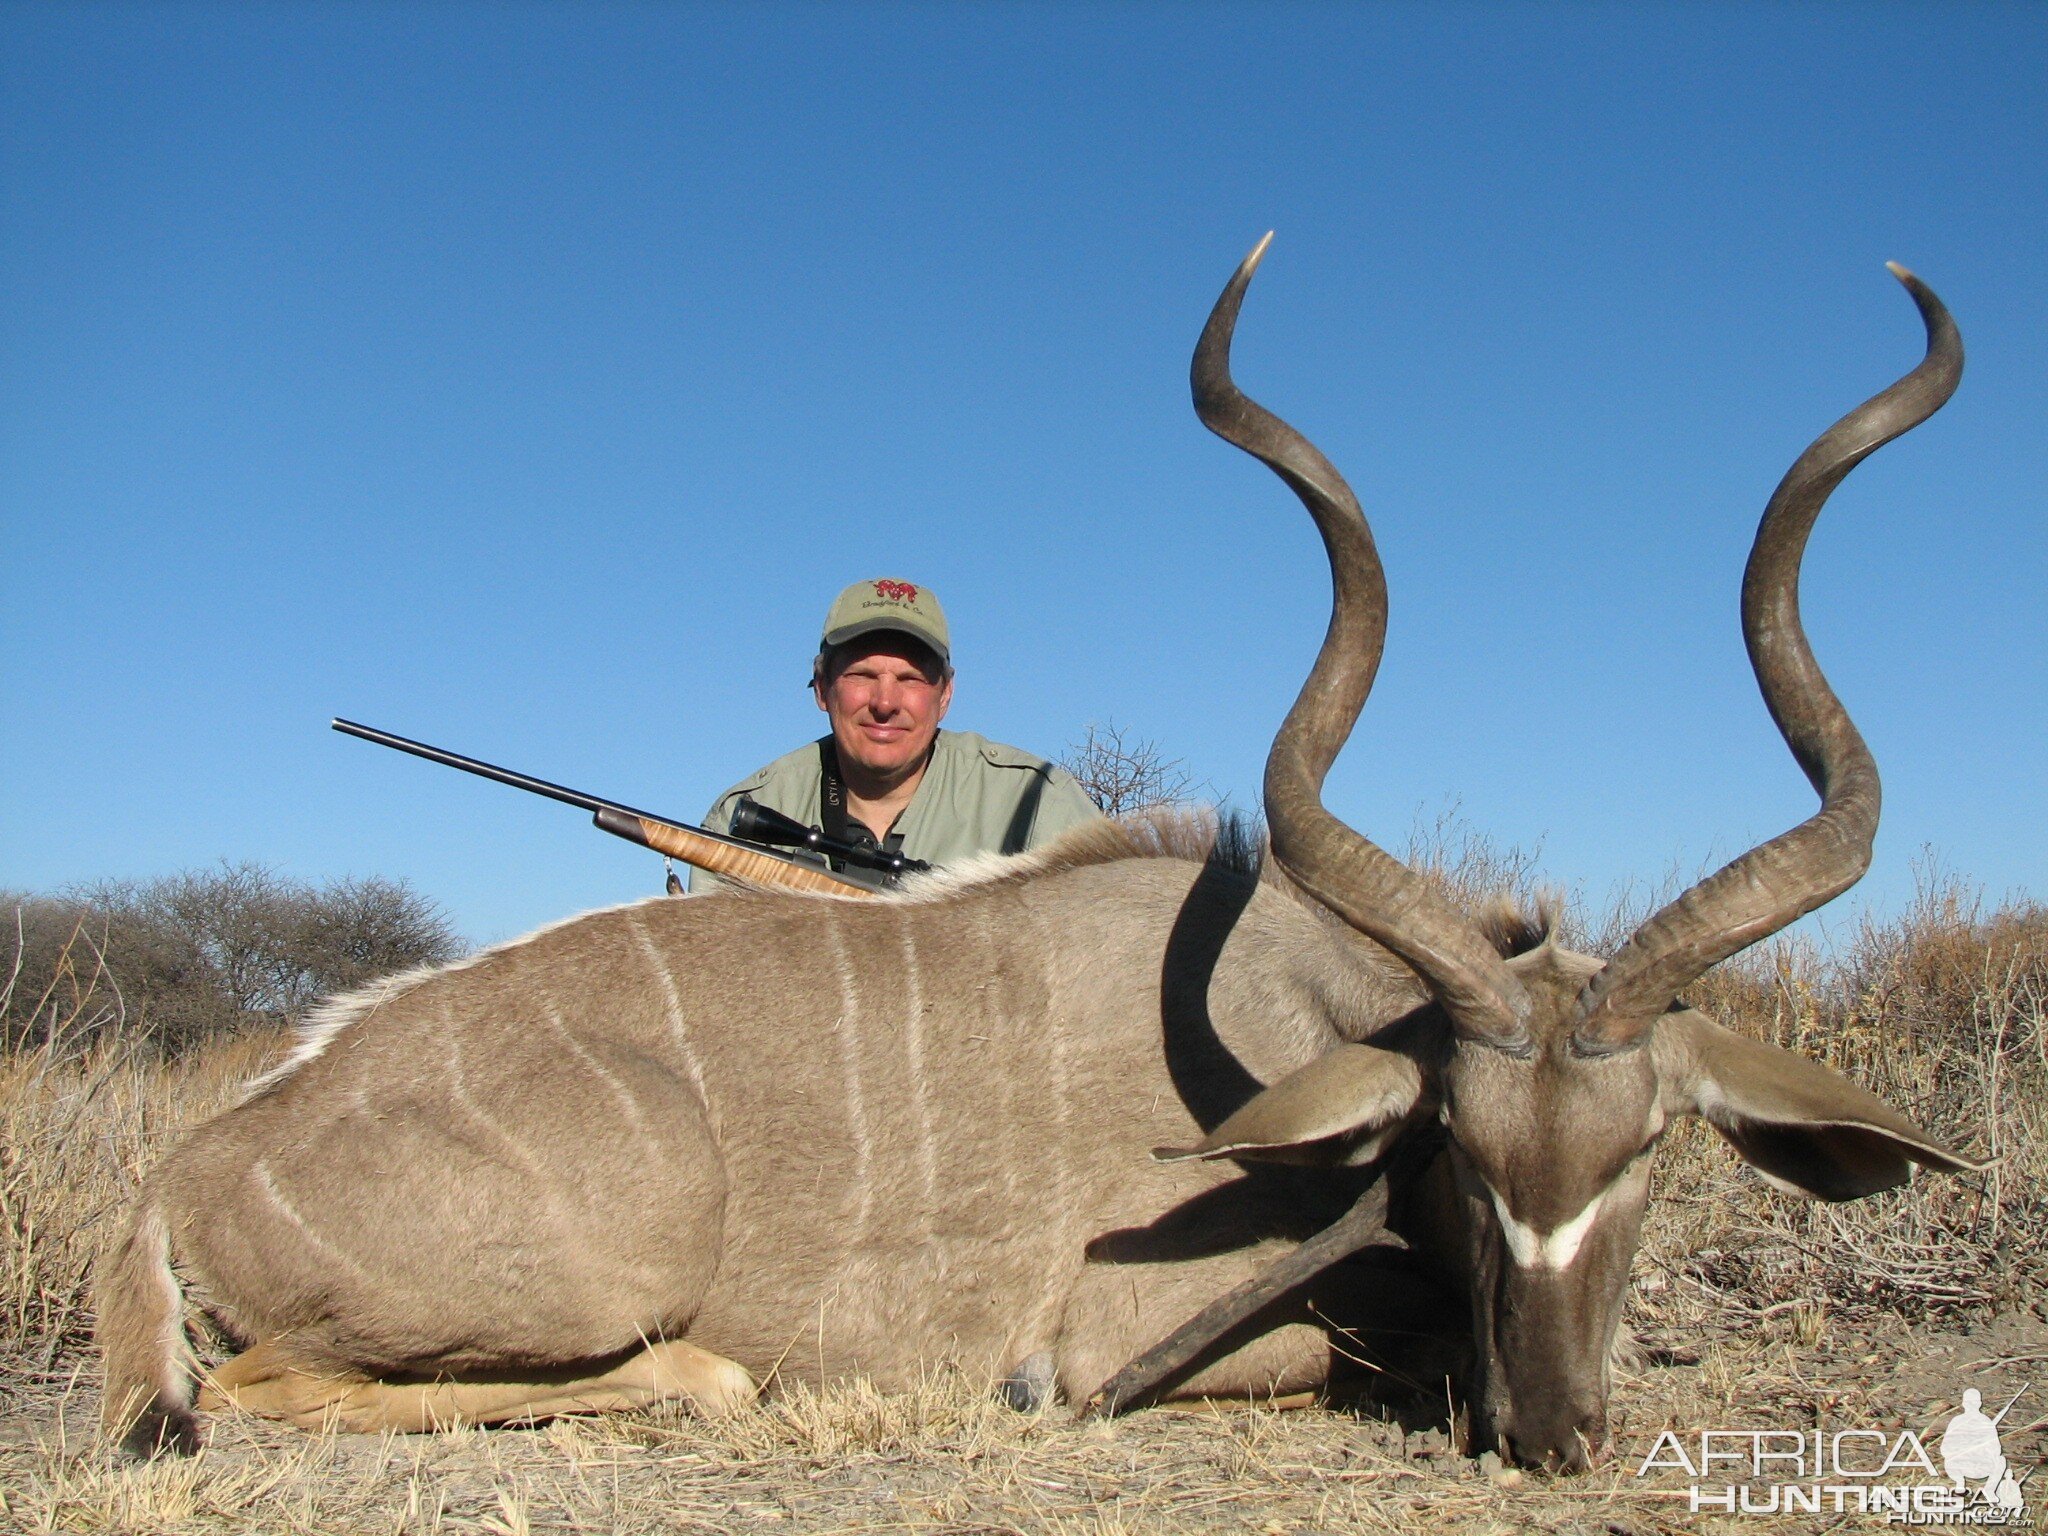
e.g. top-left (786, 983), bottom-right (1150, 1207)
top-left (0, 1309), bottom-right (2048, 1536)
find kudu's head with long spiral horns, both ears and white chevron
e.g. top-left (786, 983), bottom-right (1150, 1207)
top-left (1159, 236), bottom-right (1970, 1468)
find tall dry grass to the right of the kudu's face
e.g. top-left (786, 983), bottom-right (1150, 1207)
top-left (1638, 883), bottom-right (2048, 1319)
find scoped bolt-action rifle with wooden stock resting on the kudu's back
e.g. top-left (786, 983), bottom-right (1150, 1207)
top-left (334, 719), bottom-right (930, 895)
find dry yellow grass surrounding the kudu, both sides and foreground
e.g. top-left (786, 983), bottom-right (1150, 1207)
top-left (0, 866), bottom-right (2048, 1536)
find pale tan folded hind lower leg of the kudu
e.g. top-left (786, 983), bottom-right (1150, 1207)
top-left (199, 1339), bottom-right (758, 1434)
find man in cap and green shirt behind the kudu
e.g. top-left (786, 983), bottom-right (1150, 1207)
top-left (690, 578), bottom-right (1102, 889)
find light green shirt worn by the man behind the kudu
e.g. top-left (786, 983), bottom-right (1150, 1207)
top-left (690, 731), bottom-right (1102, 891)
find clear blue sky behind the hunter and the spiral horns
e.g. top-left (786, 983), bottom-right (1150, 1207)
top-left (0, 4), bottom-right (2048, 940)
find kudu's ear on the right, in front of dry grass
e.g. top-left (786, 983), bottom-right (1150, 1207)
top-left (1653, 1008), bottom-right (1980, 1200)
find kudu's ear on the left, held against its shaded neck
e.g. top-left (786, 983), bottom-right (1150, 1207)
top-left (1153, 1044), bottom-right (1421, 1167)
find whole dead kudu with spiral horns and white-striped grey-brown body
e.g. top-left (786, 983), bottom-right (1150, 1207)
top-left (98, 242), bottom-right (1968, 1466)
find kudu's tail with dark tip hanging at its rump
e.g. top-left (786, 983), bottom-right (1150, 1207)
top-left (92, 1200), bottom-right (199, 1456)
